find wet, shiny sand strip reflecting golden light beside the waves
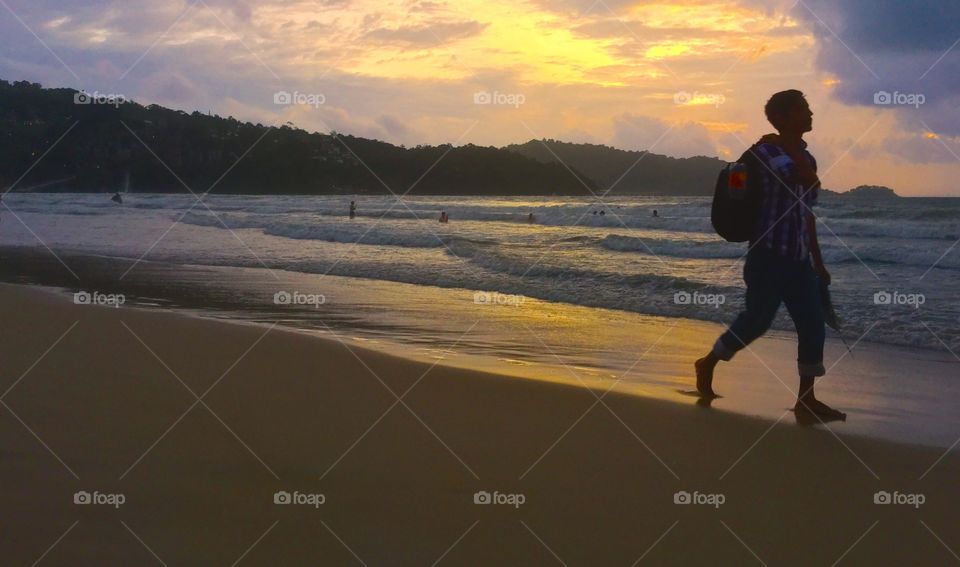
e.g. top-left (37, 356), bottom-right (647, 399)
top-left (7, 244), bottom-right (960, 448)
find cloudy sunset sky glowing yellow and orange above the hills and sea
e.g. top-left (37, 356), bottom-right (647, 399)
top-left (0, 0), bottom-right (960, 196)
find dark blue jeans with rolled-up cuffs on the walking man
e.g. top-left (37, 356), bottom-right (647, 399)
top-left (713, 246), bottom-right (826, 376)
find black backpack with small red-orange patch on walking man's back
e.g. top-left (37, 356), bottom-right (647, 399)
top-left (710, 146), bottom-right (764, 242)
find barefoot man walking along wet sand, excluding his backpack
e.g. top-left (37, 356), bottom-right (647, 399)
top-left (694, 86), bottom-right (845, 419)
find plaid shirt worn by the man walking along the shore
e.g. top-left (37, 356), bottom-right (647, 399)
top-left (750, 141), bottom-right (820, 260)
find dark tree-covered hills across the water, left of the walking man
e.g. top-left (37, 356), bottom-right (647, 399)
top-left (0, 80), bottom-right (723, 196)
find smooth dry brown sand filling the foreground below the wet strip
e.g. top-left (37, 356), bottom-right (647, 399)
top-left (0, 285), bottom-right (960, 565)
